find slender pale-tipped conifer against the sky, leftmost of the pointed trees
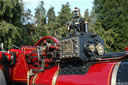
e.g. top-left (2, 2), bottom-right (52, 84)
top-left (30, 1), bottom-right (47, 43)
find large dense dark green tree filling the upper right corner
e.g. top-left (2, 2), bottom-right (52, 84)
top-left (93, 0), bottom-right (128, 51)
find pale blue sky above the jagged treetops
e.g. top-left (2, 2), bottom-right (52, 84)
top-left (23, 0), bottom-right (94, 16)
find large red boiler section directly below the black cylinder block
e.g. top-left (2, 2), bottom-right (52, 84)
top-left (56, 63), bottom-right (115, 85)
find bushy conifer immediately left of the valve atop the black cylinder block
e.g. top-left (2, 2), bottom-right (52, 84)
top-left (56, 3), bottom-right (73, 38)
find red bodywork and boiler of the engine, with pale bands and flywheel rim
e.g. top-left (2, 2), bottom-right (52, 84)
top-left (0, 36), bottom-right (127, 85)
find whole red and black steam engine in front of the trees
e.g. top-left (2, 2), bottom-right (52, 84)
top-left (0, 8), bottom-right (128, 85)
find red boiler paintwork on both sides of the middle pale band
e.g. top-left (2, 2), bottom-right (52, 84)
top-left (31, 62), bottom-right (116, 85)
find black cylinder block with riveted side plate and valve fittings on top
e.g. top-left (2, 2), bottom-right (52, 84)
top-left (60, 8), bottom-right (104, 61)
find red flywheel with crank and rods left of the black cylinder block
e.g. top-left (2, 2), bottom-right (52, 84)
top-left (28, 36), bottom-right (59, 72)
